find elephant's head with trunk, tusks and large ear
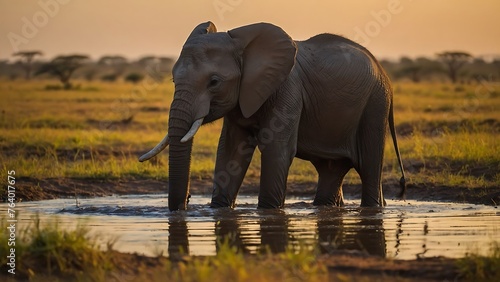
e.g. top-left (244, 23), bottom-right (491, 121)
top-left (139, 22), bottom-right (297, 210)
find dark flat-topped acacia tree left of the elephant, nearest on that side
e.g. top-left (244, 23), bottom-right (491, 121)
top-left (35, 55), bottom-right (89, 89)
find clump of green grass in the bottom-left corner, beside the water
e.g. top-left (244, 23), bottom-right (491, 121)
top-left (0, 217), bottom-right (113, 281)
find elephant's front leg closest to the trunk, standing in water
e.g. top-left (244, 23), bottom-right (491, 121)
top-left (210, 118), bottom-right (256, 208)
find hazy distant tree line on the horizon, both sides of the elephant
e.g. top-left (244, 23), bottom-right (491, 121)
top-left (0, 50), bottom-right (500, 89)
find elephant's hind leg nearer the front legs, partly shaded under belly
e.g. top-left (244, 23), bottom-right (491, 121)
top-left (313, 159), bottom-right (352, 206)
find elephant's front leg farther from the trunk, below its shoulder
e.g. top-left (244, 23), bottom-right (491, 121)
top-left (258, 142), bottom-right (296, 209)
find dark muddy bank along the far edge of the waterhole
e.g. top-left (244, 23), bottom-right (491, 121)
top-left (10, 178), bottom-right (500, 206)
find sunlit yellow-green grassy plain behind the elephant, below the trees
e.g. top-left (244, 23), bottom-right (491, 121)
top-left (0, 81), bottom-right (500, 188)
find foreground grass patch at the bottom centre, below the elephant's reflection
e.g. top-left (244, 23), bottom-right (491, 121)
top-left (157, 240), bottom-right (328, 282)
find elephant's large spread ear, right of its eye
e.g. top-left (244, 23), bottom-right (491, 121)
top-left (228, 23), bottom-right (297, 118)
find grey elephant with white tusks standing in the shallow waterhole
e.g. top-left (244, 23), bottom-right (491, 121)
top-left (139, 22), bottom-right (406, 210)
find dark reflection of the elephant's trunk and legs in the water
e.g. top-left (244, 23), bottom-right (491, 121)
top-left (168, 208), bottom-right (386, 259)
